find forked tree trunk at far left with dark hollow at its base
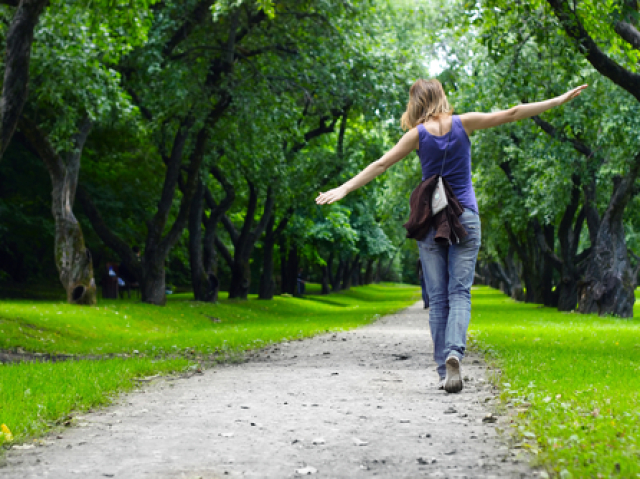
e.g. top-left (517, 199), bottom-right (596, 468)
top-left (19, 117), bottom-right (96, 304)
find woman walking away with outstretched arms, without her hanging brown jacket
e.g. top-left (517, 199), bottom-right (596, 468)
top-left (316, 79), bottom-right (587, 393)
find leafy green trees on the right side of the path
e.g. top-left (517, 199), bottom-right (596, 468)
top-left (436, 0), bottom-right (640, 317)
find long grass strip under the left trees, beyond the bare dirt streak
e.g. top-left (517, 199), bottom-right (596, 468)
top-left (0, 285), bottom-right (417, 355)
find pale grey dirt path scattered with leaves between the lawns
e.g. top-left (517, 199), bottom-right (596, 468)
top-left (0, 304), bottom-right (537, 479)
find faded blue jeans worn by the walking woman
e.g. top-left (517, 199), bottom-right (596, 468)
top-left (418, 210), bottom-right (480, 377)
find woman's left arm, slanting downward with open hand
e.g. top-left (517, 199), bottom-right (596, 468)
top-left (316, 128), bottom-right (418, 205)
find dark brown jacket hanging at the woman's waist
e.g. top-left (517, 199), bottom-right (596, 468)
top-left (404, 175), bottom-right (467, 245)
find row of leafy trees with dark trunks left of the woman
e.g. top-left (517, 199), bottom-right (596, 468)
top-left (0, 0), bottom-right (424, 304)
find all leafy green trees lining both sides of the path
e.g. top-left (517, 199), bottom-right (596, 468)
top-left (0, 0), bottom-right (640, 317)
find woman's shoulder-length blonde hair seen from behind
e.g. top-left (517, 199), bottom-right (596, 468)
top-left (400, 78), bottom-right (453, 130)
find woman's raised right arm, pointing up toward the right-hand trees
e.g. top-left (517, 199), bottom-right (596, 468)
top-left (460, 85), bottom-right (588, 135)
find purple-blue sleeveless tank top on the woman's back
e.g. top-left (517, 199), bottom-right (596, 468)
top-left (417, 115), bottom-right (479, 214)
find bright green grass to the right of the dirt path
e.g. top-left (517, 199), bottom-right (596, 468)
top-left (470, 287), bottom-right (640, 479)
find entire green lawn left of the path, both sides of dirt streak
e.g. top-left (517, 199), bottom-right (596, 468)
top-left (0, 284), bottom-right (420, 443)
